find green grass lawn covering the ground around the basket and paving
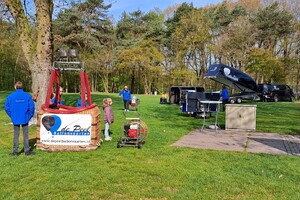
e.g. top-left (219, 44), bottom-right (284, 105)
top-left (0, 92), bottom-right (300, 200)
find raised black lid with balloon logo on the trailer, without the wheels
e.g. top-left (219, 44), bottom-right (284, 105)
top-left (204, 64), bottom-right (257, 92)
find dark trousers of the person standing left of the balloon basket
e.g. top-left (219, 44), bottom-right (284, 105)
top-left (14, 124), bottom-right (30, 153)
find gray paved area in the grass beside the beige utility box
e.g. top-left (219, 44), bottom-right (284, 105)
top-left (172, 129), bottom-right (300, 156)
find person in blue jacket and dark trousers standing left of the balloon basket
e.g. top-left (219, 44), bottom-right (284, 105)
top-left (4, 81), bottom-right (35, 156)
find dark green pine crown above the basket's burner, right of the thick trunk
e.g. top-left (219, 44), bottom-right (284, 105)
top-left (53, 0), bottom-right (113, 52)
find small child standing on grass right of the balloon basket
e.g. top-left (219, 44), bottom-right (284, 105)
top-left (102, 98), bottom-right (114, 141)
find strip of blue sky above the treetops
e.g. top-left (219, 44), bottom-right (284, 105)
top-left (104, 0), bottom-right (223, 21)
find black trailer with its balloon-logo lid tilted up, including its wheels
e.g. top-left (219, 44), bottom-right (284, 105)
top-left (204, 64), bottom-right (259, 103)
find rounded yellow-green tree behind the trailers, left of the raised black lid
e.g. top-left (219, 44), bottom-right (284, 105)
top-left (171, 10), bottom-right (211, 84)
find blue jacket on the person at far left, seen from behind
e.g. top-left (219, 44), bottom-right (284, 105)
top-left (4, 89), bottom-right (34, 125)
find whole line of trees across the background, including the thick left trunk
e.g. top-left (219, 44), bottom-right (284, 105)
top-left (0, 0), bottom-right (300, 97)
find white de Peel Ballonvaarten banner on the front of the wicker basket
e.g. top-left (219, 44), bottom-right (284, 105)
top-left (40, 114), bottom-right (92, 145)
